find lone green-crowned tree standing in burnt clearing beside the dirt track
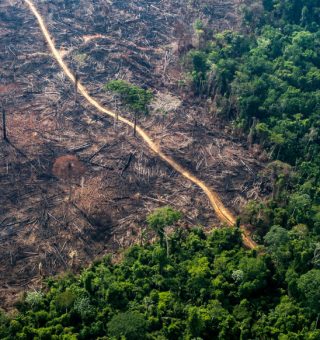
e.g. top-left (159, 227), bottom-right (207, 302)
top-left (104, 80), bottom-right (153, 136)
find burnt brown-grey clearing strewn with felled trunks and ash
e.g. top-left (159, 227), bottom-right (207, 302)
top-left (0, 0), bottom-right (262, 307)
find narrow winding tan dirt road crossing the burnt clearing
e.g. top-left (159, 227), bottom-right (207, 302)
top-left (25, 0), bottom-right (257, 249)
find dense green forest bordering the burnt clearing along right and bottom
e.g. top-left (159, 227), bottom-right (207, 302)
top-left (0, 0), bottom-right (320, 340)
